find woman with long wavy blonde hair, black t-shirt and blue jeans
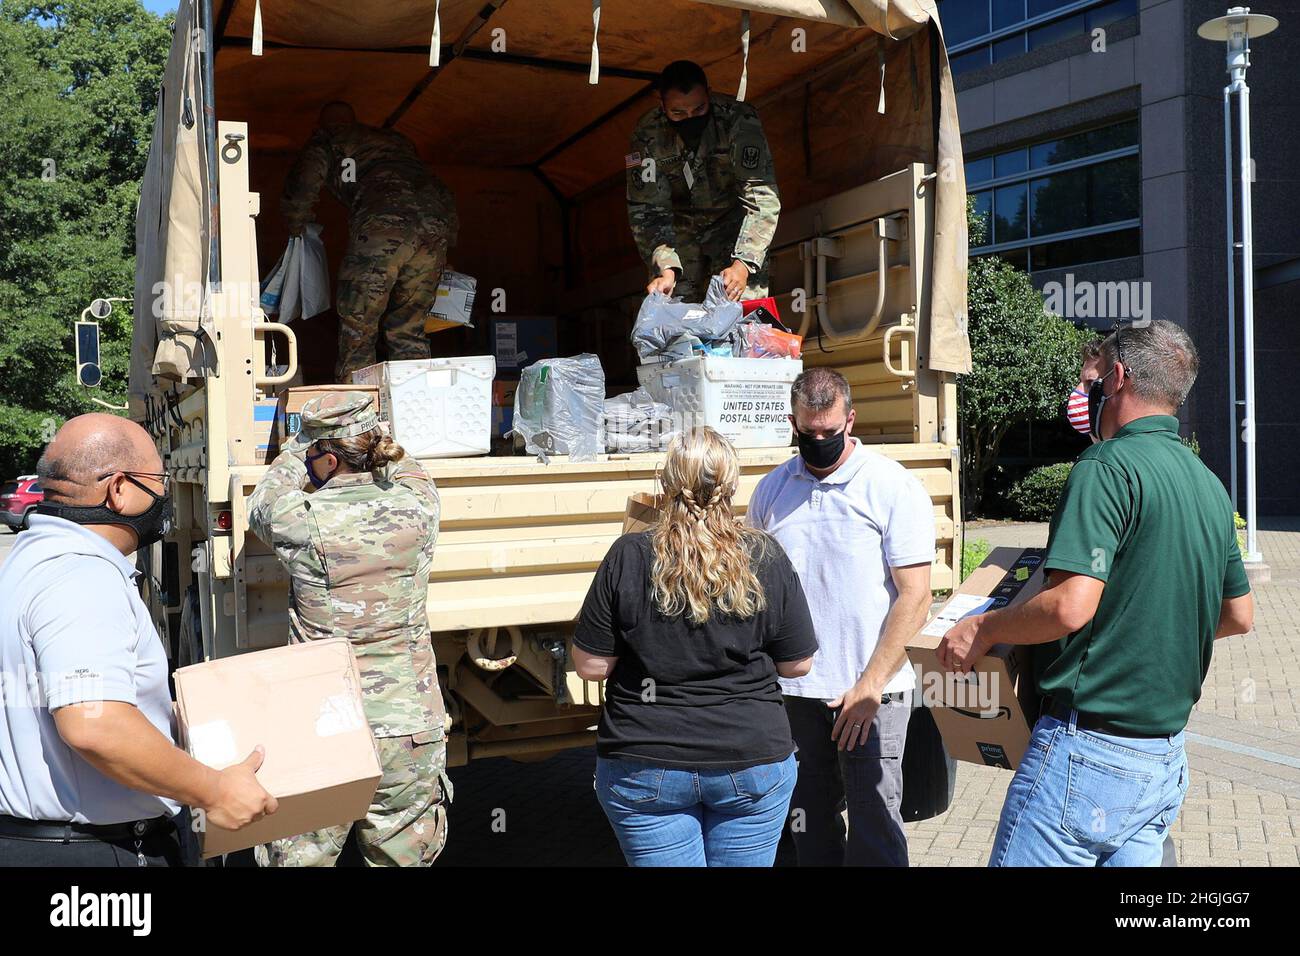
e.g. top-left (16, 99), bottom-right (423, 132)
top-left (573, 428), bottom-right (816, 866)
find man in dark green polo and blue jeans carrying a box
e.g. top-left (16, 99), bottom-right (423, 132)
top-left (939, 321), bottom-right (1255, 866)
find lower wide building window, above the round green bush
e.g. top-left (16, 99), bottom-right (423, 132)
top-left (966, 119), bottom-right (1141, 272)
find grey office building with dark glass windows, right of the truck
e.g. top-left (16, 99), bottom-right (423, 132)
top-left (937, 0), bottom-right (1300, 515)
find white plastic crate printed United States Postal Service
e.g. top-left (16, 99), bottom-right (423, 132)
top-left (637, 355), bottom-right (803, 449)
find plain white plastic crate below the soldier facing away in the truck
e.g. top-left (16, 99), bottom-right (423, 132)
top-left (352, 355), bottom-right (497, 458)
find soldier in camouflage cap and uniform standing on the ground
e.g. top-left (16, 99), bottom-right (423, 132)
top-left (248, 392), bottom-right (451, 866)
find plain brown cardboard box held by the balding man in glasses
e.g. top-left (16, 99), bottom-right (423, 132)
top-left (176, 637), bottom-right (382, 858)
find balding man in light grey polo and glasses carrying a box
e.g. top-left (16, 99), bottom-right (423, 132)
top-left (0, 415), bottom-right (276, 866)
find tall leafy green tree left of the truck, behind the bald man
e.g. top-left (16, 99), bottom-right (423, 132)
top-left (0, 0), bottom-right (172, 479)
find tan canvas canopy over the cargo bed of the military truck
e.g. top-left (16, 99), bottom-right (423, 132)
top-left (131, 0), bottom-right (970, 408)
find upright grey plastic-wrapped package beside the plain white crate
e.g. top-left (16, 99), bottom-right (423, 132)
top-left (514, 352), bottom-right (605, 462)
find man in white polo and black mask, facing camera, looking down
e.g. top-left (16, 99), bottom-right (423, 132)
top-left (749, 368), bottom-right (935, 866)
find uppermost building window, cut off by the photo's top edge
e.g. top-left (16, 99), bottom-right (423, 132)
top-left (939, 0), bottom-right (1138, 77)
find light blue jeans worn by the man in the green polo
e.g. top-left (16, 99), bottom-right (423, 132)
top-left (988, 711), bottom-right (1187, 866)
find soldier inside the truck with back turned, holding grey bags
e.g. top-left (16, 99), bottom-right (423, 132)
top-left (280, 103), bottom-right (459, 382)
